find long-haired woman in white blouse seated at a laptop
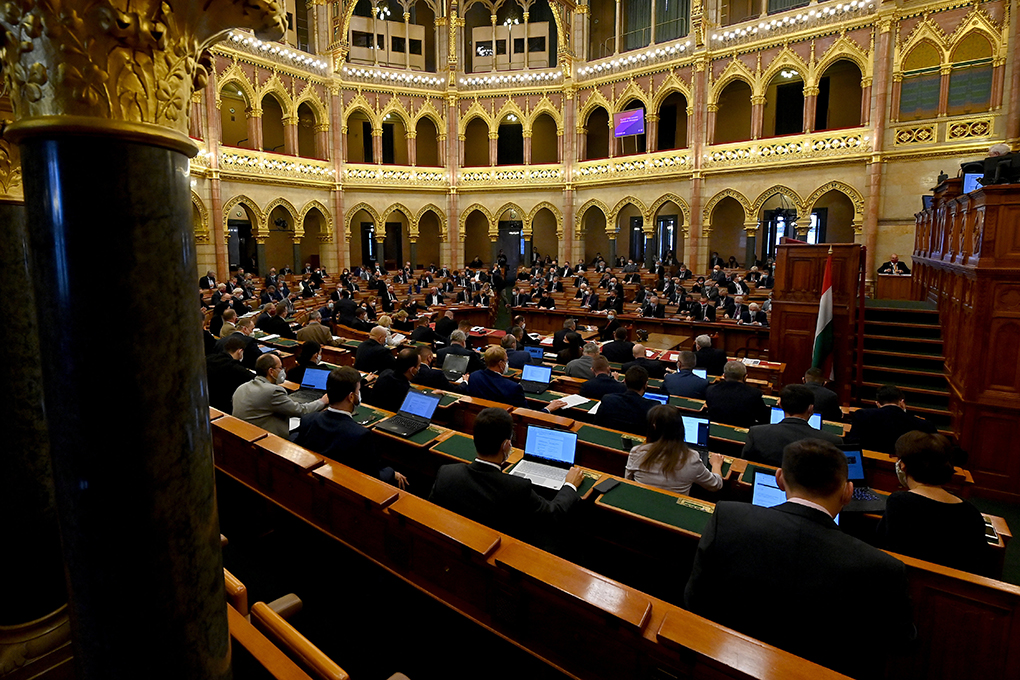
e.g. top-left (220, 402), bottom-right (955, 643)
top-left (625, 405), bottom-right (722, 493)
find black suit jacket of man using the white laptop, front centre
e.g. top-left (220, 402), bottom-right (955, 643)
top-left (428, 456), bottom-right (580, 545)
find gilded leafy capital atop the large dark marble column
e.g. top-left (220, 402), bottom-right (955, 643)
top-left (0, 0), bottom-right (286, 140)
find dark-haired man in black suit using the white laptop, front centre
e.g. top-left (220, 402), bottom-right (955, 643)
top-left (428, 408), bottom-right (583, 547)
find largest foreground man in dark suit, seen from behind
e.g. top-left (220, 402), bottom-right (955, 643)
top-left (683, 439), bottom-right (914, 678)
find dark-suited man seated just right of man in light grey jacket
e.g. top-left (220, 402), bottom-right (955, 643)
top-left (294, 366), bottom-right (407, 488)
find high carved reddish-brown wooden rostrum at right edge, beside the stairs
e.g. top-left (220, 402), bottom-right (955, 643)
top-left (913, 179), bottom-right (1020, 503)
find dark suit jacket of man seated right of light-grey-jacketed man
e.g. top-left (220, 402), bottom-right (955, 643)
top-left (294, 409), bottom-right (394, 482)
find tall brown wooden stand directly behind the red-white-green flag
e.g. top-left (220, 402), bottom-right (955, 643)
top-left (769, 244), bottom-right (863, 402)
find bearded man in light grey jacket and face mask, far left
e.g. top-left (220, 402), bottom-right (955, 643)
top-left (232, 352), bottom-right (328, 437)
